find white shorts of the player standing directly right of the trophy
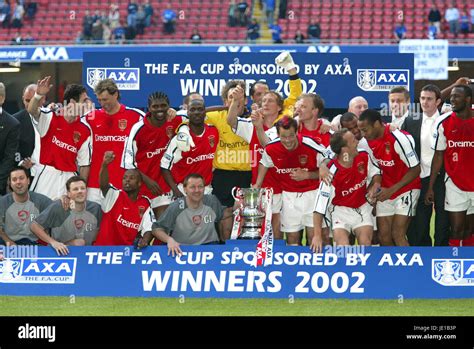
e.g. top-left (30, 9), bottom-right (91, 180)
top-left (281, 189), bottom-right (317, 233)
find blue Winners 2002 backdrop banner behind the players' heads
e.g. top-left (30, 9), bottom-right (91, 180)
top-left (83, 52), bottom-right (414, 108)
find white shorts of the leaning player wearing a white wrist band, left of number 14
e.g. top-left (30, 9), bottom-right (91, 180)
top-left (331, 203), bottom-right (374, 233)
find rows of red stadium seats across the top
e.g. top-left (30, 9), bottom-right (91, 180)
top-left (0, 0), bottom-right (474, 44)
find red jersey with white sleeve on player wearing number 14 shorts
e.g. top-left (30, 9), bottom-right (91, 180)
top-left (367, 125), bottom-right (421, 199)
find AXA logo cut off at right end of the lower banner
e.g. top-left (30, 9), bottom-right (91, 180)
top-left (431, 259), bottom-right (474, 286)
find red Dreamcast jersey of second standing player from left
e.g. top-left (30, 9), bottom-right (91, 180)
top-left (82, 105), bottom-right (145, 188)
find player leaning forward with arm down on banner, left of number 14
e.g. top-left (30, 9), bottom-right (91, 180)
top-left (310, 128), bottom-right (382, 253)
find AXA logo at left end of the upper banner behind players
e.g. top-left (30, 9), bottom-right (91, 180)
top-left (87, 68), bottom-right (140, 90)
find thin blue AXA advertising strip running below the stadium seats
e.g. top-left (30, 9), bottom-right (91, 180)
top-left (0, 44), bottom-right (474, 62)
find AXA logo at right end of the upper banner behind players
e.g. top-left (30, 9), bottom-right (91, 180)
top-left (357, 69), bottom-right (410, 92)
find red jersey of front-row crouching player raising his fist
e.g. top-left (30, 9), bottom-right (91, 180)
top-left (94, 186), bottom-right (150, 246)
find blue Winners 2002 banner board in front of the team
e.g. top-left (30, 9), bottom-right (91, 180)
top-left (0, 241), bottom-right (474, 299)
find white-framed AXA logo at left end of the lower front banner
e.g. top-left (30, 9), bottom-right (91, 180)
top-left (0, 258), bottom-right (77, 284)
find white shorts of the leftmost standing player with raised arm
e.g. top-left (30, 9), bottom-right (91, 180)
top-left (30, 165), bottom-right (76, 201)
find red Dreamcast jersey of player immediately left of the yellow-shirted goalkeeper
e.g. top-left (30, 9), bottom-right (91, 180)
top-left (161, 125), bottom-right (219, 185)
